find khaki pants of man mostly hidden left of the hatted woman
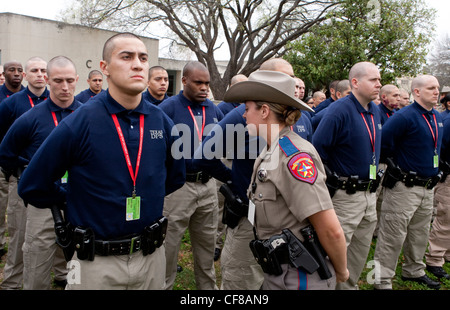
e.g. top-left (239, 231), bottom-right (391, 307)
top-left (220, 217), bottom-right (264, 290)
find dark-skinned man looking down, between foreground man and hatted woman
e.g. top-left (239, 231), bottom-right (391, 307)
top-left (159, 61), bottom-right (223, 290)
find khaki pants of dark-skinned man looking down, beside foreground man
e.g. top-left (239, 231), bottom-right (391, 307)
top-left (163, 179), bottom-right (218, 290)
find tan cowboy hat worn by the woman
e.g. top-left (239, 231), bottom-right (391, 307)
top-left (224, 70), bottom-right (314, 112)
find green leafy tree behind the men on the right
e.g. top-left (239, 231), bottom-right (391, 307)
top-left (285, 0), bottom-right (436, 90)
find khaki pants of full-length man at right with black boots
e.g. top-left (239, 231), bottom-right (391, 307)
top-left (374, 182), bottom-right (433, 289)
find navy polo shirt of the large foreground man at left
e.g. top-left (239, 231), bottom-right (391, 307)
top-left (18, 92), bottom-right (185, 240)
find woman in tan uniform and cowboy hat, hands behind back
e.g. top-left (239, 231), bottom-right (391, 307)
top-left (224, 70), bottom-right (348, 290)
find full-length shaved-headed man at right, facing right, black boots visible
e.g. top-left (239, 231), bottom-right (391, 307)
top-left (375, 75), bottom-right (443, 289)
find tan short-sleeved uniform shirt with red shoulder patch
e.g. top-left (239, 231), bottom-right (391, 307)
top-left (248, 128), bottom-right (333, 241)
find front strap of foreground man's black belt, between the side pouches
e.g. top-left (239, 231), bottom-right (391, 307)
top-left (95, 236), bottom-right (142, 256)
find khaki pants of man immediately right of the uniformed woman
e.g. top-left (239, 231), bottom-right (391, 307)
top-left (332, 190), bottom-right (377, 290)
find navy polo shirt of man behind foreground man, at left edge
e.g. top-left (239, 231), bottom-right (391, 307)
top-left (0, 99), bottom-right (81, 169)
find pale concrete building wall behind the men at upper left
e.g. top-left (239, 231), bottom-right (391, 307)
top-left (0, 13), bottom-right (159, 94)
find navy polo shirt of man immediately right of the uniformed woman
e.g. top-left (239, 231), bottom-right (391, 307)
top-left (313, 94), bottom-right (381, 180)
